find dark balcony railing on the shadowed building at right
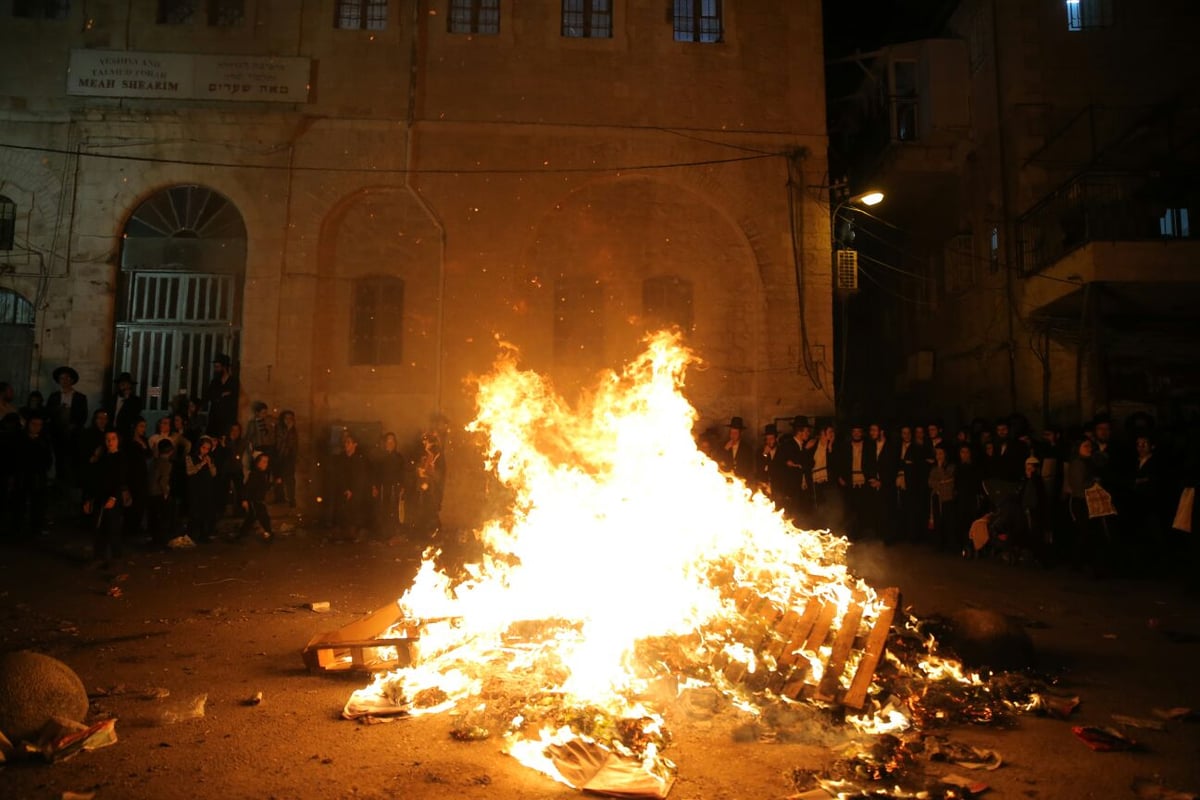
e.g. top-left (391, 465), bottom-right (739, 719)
top-left (1016, 172), bottom-right (1196, 275)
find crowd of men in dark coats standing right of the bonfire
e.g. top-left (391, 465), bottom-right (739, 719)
top-left (704, 415), bottom-right (1196, 573)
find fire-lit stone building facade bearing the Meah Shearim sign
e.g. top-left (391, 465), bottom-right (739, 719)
top-left (0, 0), bottom-right (833, 525)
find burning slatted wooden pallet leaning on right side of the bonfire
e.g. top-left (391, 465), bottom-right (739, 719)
top-left (715, 588), bottom-right (900, 710)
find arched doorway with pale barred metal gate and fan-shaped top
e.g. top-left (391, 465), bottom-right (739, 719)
top-left (113, 185), bottom-right (246, 411)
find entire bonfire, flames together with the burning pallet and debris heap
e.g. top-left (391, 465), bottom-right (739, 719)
top-left (338, 333), bottom-right (916, 796)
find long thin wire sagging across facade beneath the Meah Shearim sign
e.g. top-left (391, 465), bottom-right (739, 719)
top-left (0, 142), bottom-right (786, 175)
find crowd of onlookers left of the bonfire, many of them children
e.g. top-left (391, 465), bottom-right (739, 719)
top-left (0, 354), bottom-right (445, 564)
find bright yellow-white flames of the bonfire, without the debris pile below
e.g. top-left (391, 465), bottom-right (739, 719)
top-left (356, 333), bottom-right (892, 777)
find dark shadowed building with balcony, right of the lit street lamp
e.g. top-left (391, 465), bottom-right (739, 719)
top-left (851, 0), bottom-right (1200, 426)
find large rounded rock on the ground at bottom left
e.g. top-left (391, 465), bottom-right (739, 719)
top-left (0, 650), bottom-right (88, 744)
